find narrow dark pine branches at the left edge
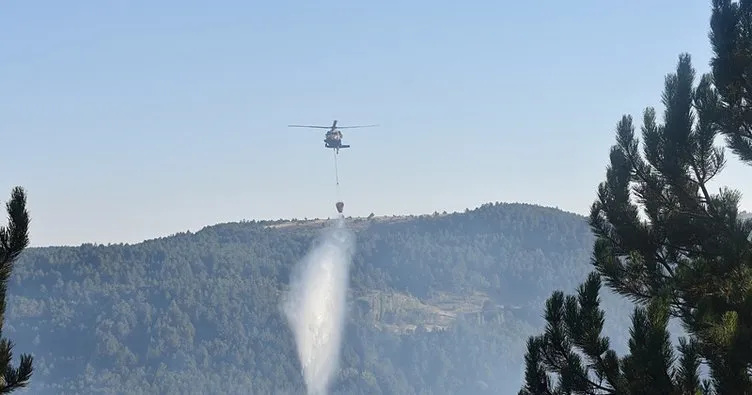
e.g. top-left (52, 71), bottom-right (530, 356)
top-left (0, 187), bottom-right (33, 393)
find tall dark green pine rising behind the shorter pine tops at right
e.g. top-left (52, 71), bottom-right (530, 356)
top-left (590, 55), bottom-right (752, 393)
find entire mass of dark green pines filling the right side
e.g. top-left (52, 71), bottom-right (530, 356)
top-left (520, 7), bottom-right (752, 395)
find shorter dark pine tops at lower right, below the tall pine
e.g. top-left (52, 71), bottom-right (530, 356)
top-left (519, 272), bottom-right (709, 395)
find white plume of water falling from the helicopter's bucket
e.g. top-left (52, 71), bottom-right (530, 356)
top-left (283, 218), bottom-right (355, 395)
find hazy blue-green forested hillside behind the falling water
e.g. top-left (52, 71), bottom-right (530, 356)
top-left (6, 204), bottom-right (628, 394)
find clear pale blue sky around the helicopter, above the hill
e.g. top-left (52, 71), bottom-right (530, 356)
top-left (0, 0), bottom-right (752, 245)
